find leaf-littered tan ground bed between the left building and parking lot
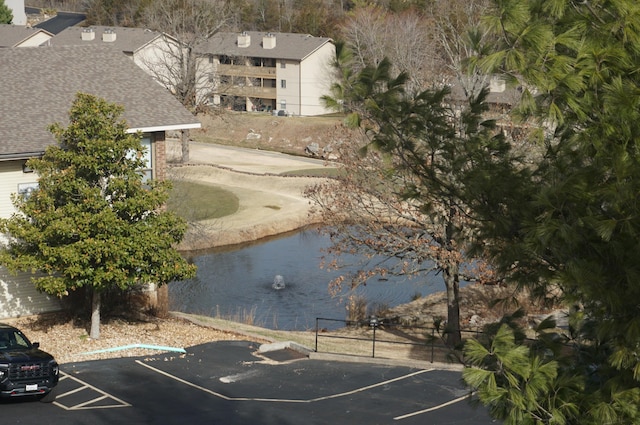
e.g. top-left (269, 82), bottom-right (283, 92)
top-left (3, 314), bottom-right (262, 364)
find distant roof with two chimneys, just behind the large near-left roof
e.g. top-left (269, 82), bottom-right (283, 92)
top-left (50, 26), bottom-right (168, 53)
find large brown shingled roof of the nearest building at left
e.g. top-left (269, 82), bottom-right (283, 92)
top-left (0, 46), bottom-right (200, 159)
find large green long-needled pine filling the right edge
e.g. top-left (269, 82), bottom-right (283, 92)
top-left (465, 0), bottom-right (640, 424)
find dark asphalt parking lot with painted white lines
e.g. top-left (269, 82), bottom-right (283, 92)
top-left (1, 341), bottom-right (493, 425)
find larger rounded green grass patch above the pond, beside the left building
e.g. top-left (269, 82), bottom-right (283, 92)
top-left (167, 180), bottom-right (240, 222)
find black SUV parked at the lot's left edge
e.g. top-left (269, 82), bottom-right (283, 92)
top-left (0, 323), bottom-right (60, 402)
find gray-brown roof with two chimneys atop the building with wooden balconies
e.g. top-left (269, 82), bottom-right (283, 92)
top-left (198, 31), bottom-right (331, 61)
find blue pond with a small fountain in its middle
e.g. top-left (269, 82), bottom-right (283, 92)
top-left (169, 230), bottom-right (443, 330)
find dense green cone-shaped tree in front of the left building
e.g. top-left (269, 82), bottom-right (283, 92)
top-left (0, 93), bottom-right (195, 338)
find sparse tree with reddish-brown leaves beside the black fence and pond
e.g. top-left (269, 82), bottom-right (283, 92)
top-left (306, 121), bottom-right (494, 346)
